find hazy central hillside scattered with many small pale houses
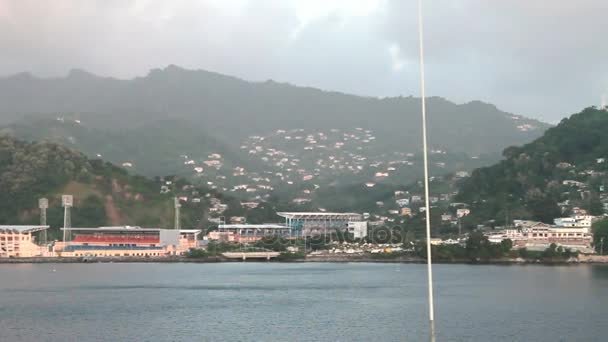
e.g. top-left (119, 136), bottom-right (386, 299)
top-left (164, 128), bottom-right (482, 205)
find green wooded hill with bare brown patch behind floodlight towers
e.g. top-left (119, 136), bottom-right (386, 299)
top-left (0, 135), bottom-right (222, 239)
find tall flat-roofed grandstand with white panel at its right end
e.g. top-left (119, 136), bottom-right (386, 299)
top-left (277, 212), bottom-right (367, 238)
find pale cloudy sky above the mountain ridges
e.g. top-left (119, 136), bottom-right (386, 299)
top-left (0, 0), bottom-right (608, 123)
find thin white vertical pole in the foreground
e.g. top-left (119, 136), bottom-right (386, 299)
top-left (418, 0), bottom-right (435, 342)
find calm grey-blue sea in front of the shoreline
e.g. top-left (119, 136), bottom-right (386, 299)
top-left (0, 263), bottom-right (608, 342)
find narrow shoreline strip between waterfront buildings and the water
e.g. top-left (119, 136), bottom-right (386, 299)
top-left (0, 255), bottom-right (608, 266)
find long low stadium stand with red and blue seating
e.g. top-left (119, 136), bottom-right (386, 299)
top-left (53, 226), bottom-right (201, 257)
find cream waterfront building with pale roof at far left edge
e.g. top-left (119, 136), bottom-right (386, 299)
top-left (0, 225), bottom-right (49, 258)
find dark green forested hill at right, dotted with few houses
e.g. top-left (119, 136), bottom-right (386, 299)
top-left (457, 107), bottom-right (608, 223)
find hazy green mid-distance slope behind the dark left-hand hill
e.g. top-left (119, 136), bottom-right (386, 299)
top-left (0, 117), bottom-right (249, 177)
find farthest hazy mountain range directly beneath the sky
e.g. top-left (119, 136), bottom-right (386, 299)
top-left (0, 66), bottom-right (548, 155)
